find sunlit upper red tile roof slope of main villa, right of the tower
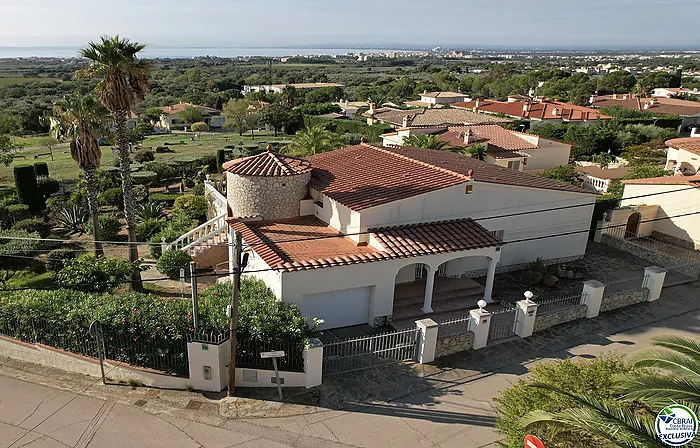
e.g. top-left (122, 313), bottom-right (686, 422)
top-left (308, 145), bottom-right (469, 210)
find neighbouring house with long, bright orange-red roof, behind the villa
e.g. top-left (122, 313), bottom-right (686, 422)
top-left (452, 97), bottom-right (612, 125)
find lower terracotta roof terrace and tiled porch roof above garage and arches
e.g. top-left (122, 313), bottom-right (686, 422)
top-left (229, 216), bottom-right (503, 272)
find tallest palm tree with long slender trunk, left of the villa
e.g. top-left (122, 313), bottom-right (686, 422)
top-left (77, 36), bottom-right (150, 290)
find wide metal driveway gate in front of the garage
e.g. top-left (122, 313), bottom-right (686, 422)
top-left (323, 328), bottom-right (420, 375)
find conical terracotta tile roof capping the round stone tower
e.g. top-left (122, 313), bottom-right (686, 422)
top-left (223, 151), bottom-right (311, 177)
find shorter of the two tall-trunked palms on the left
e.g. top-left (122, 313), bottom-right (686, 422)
top-left (50, 93), bottom-right (109, 256)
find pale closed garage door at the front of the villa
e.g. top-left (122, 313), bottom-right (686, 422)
top-left (301, 286), bottom-right (372, 329)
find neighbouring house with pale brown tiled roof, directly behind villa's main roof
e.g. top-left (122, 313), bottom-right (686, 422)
top-left (363, 104), bottom-right (510, 128)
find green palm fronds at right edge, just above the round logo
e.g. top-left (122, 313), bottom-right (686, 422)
top-left (618, 336), bottom-right (700, 410)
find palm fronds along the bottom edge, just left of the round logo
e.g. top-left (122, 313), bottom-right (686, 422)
top-left (521, 383), bottom-right (666, 448)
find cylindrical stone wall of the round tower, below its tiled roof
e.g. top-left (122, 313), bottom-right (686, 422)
top-left (226, 173), bottom-right (311, 219)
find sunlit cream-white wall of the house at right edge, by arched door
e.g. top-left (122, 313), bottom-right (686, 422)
top-left (621, 185), bottom-right (700, 247)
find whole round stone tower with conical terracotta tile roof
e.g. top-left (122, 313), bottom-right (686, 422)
top-left (224, 146), bottom-right (311, 220)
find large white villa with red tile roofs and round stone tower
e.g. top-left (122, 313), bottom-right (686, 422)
top-left (209, 144), bottom-right (596, 328)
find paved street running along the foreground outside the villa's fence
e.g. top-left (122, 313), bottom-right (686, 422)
top-left (0, 311), bottom-right (700, 448)
